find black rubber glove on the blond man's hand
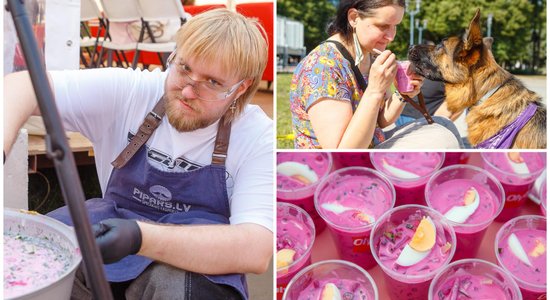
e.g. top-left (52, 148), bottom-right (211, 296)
top-left (92, 219), bottom-right (141, 264)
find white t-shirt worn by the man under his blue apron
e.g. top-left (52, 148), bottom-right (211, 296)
top-left (50, 68), bottom-right (274, 231)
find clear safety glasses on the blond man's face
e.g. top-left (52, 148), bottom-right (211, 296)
top-left (170, 54), bottom-right (244, 101)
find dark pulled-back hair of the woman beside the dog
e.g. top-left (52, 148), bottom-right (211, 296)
top-left (327, 0), bottom-right (405, 43)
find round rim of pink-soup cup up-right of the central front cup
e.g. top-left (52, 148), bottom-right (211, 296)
top-left (424, 164), bottom-right (506, 229)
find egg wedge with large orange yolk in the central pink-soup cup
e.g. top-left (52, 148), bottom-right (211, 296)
top-left (396, 216), bottom-right (436, 267)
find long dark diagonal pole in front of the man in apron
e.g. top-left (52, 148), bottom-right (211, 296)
top-left (8, 0), bottom-right (113, 300)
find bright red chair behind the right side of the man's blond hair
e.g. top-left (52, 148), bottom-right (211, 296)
top-left (236, 2), bottom-right (274, 88)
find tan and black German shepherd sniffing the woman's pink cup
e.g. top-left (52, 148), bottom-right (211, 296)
top-left (409, 9), bottom-right (546, 149)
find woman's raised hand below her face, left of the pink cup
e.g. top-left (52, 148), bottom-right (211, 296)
top-left (367, 50), bottom-right (397, 94)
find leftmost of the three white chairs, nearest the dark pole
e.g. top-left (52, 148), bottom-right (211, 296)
top-left (80, 0), bottom-right (106, 68)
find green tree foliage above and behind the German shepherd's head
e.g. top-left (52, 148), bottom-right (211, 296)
top-left (412, 0), bottom-right (546, 68)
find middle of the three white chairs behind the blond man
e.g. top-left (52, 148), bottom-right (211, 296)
top-left (100, 0), bottom-right (141, 67)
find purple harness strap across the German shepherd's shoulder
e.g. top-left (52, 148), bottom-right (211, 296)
top-left (475, 103), bottom-right (537, 149)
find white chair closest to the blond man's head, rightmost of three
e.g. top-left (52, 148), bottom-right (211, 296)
top-left (132, 0), bottom-right (191, 68)
